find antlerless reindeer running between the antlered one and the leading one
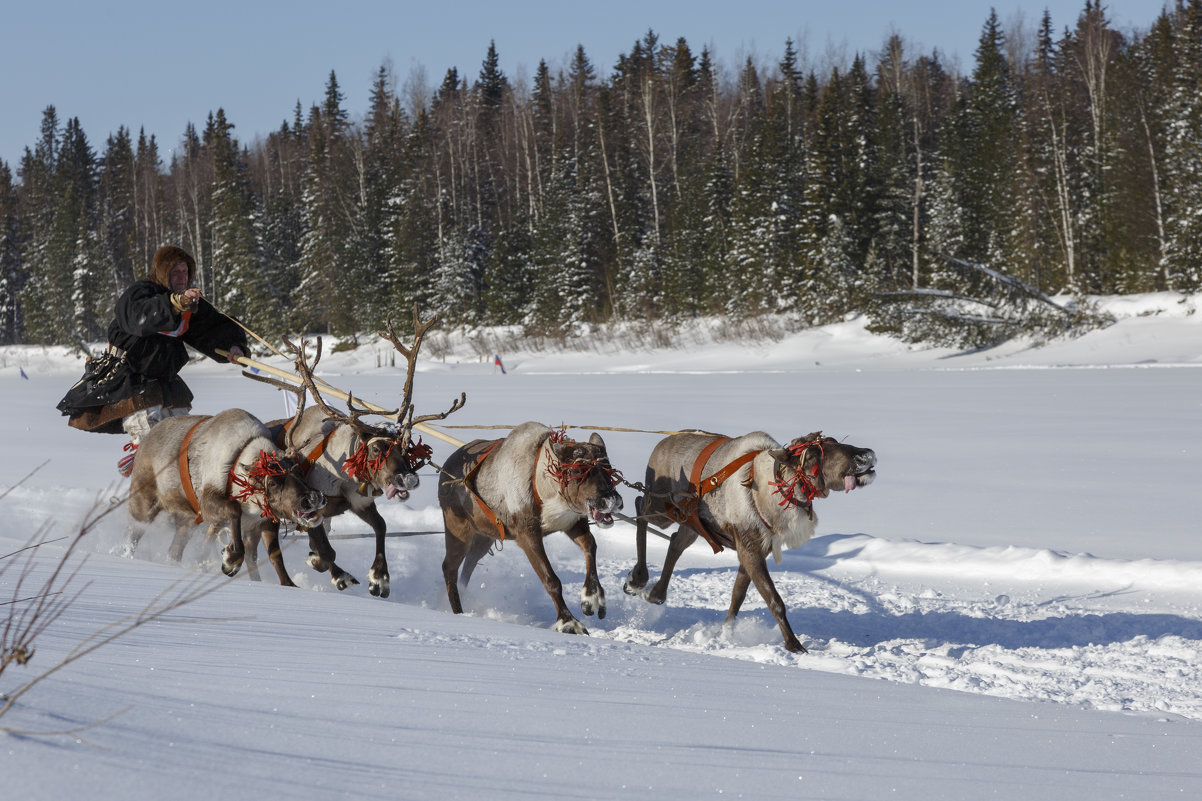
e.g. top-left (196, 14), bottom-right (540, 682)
top-left (439, 422), bottom-right (621, 634)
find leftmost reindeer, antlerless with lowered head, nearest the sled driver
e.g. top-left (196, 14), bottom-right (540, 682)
top-left (127, 409), bottom-right (328, 579)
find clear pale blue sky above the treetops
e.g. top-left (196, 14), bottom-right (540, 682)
top-left (0, 0), bottom-right (1162, 170)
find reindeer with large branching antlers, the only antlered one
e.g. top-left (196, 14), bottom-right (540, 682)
top-left (256, 305), bottom-right (468, 598)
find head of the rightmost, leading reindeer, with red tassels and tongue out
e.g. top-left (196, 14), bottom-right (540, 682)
top-left (768, 432), bottom-right (876, 506)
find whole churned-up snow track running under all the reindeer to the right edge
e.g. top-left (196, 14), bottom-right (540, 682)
top-left (68, 491), bottom-right (1202, 720)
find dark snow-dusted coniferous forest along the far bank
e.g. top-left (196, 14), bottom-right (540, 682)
top-left (0, 0), bottom-right (1202, 346)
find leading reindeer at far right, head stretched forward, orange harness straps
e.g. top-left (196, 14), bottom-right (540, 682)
top-left (623, 432), bottom-right (876, 652)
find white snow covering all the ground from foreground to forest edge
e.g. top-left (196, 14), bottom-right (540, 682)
top-left (0, 295), bottom-right (1202, 801)
